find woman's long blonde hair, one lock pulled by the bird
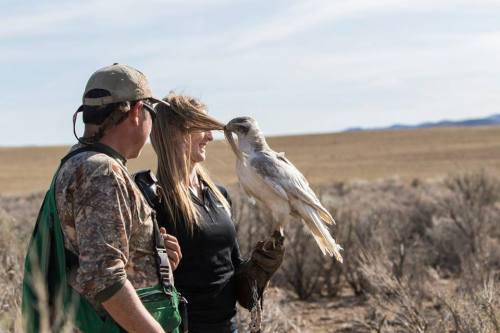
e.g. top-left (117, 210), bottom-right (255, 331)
top-left (151, 93), bottom-right (230, 233)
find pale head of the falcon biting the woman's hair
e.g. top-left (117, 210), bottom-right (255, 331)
top-left (224, 117), bottom-right (264, 159)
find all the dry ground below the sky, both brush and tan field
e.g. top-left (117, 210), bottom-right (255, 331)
top-left (0, 127), bottom-right (500, 333)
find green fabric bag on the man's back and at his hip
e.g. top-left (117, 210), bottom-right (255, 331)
top-left (22, 167), bottom-right (181, 333)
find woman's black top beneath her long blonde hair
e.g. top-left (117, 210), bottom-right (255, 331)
top-left (157, 184), bottom-right (242, 333)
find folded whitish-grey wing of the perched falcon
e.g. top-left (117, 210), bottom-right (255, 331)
top-left (250, 151), bottom-right (335, 224)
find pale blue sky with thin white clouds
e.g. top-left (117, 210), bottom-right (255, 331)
top-left (0, 0), bottom-right (500, 146)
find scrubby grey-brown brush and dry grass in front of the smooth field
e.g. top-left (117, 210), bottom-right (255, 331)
top-left (0, 173), bottom-right (500, 333)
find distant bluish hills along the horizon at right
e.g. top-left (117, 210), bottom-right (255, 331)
top-left (346, 114), bottom-right (500, 132)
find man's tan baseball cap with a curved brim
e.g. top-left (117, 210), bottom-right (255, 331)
top-left (82, 63), bottom-right (168, 106)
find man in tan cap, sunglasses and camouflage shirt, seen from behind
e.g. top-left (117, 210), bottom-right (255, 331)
top-left (23, 64), bottom-right (181, 332)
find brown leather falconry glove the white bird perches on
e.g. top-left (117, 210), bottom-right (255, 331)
top-left (236, 231), bottom-right (285, 310)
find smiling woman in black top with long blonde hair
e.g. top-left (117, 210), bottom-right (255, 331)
top-left (151, 94), bottom-right (242, 333)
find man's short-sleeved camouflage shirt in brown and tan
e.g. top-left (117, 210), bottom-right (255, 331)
top-left (55, 146), bottom-right (159, 310)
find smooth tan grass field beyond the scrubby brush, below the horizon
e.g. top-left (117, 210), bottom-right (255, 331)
top-left (0, 127), bottom-right (500, 194)
